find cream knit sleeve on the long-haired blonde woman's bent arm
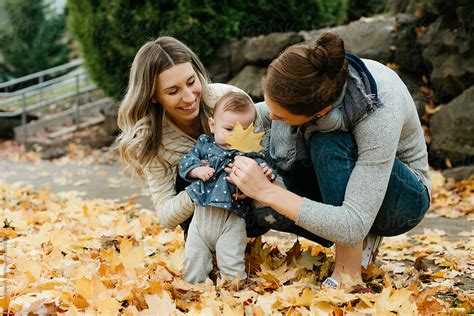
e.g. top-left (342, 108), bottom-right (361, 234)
top-left (145, 163), bottom-right (194, 229)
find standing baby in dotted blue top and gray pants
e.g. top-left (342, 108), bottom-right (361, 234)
top-left (179, 92), bottom-right (274, 284)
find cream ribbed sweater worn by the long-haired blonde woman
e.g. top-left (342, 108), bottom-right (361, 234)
top-left (144, 83), bottom-right (270, 228)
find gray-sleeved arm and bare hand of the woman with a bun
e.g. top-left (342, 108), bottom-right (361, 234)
top-left (230, 96), bottom-right (403, 247)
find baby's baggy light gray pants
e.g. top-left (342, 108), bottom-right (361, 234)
top-left (184, 206), bottom-right (247, 284)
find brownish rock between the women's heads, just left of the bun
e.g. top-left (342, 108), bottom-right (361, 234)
top-left (231, 32), bottom-right (304, 74)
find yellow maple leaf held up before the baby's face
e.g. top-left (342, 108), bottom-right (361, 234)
top-left (224, 122), bottom-right (265, 153)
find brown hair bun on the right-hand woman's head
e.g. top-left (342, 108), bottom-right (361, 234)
top-left (309, 32), bottom-right (346, 76)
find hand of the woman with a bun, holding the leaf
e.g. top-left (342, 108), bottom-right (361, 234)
top-left (229, 156), bottom-right (272, 201)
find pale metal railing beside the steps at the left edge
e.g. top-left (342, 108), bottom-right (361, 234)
top-left (0, 59), bottom-right (102, 143)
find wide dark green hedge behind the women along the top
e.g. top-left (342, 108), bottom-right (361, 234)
top-left (68, 0), bottom-right (388, 99)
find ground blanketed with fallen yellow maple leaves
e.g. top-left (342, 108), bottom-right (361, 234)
top-left (0, 174), bottom-right (474, 315)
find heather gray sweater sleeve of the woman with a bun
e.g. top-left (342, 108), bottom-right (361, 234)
top-left (296, 91), bottom-right (404, 247)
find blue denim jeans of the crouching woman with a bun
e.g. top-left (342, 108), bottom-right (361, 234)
top-left (283, 132), bottom-right (430, 236)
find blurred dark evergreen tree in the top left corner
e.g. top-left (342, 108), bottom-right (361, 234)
top-left (0, 0), bottom-right (68, 79)
